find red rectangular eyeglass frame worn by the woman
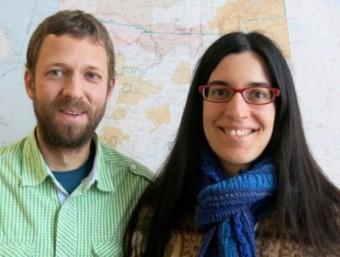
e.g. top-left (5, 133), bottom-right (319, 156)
top-left (198, 85), bottom-right (281, 105)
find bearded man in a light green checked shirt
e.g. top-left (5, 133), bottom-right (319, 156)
top-left (0, 11), bottom-right (152, 257)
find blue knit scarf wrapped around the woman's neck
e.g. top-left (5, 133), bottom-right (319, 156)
top-left (196, 151), bottom-right (277, 257)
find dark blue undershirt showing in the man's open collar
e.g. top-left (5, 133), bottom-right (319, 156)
top-left (52, 143), bottom-right (95, 194)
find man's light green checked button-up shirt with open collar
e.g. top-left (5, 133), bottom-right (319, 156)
top-left (0, 133), bottom-right (152, 257)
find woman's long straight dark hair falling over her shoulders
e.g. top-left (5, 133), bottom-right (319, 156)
top-left (124, 32), bottom-right (340, 257)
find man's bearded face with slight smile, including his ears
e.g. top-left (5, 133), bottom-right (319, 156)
top-left (25, 34), bottom-right (113, 148)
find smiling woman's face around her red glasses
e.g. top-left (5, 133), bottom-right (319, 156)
top-left (203, 52), bottom-right (275, 176)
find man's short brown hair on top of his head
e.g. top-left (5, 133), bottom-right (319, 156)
top-left (26, 10), bottom-right (115, 80)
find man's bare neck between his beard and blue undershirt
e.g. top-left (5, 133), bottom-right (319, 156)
top-left (36, 129), bottom-right (91, 171)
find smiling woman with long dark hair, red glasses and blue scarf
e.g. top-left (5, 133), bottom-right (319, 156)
top-left (125, 32), bottom-right (340, 257)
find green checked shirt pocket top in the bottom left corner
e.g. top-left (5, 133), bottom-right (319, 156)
top-left (0, 242), bottom-right (33, 257)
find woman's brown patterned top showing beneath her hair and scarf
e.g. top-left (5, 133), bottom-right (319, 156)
top-left (134, 210), bottom-right (340, 257)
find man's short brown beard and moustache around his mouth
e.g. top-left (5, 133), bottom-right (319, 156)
top-left (33, 97), bottom-right (106, 149)
